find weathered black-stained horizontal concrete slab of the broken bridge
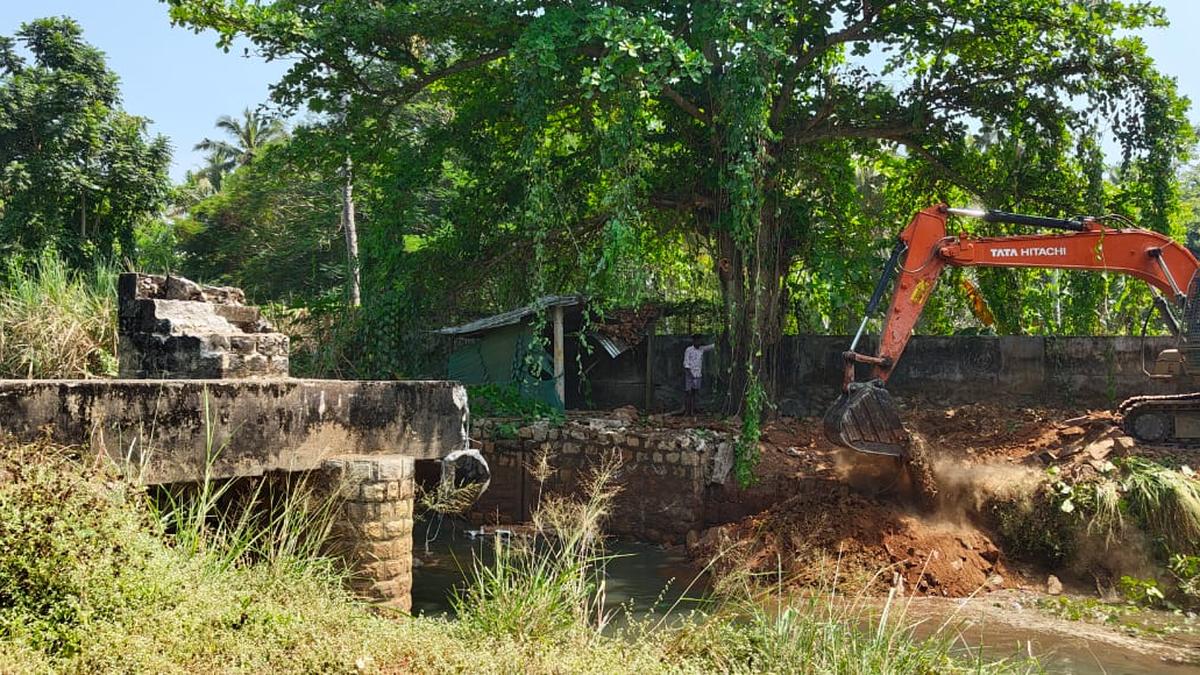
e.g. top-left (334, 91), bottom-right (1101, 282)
top-left (0, 378), bottom-right (467, 484)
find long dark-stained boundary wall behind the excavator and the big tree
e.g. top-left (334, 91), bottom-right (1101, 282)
top-left (583, 335), bottom-right (1177, 416)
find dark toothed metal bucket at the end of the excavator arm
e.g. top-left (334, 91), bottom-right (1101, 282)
top-left (824, 380), bottom-right (910, 456)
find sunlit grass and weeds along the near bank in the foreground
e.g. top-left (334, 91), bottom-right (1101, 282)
top-left (0, 443), bottom-right (1024, 673)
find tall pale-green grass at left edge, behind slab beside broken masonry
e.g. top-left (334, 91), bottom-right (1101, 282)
top-left (0, 251), bottom-right (118, 378)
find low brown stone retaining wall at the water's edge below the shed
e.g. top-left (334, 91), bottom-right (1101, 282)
top-left (470, 418), bottom-right (733, 543)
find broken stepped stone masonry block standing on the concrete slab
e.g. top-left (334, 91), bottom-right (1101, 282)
top-left (118, 274), bottom-right (289, 378)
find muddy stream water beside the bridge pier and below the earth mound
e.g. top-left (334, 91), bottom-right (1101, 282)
top-left (413, 526), bottom-right (1200, 675)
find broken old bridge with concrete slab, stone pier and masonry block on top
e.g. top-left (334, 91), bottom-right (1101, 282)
top-left (0, 274), bottom-right (467, 610)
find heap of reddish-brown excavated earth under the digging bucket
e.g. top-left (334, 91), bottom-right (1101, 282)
top-left (688, 401), bottom-right (1153, 597)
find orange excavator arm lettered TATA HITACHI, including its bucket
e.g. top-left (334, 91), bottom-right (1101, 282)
top-left (824, 205), bottom-right (1200, 456)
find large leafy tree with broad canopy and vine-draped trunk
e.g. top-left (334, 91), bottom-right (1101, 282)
top-left (167, 0), bottom-right (1189, 418)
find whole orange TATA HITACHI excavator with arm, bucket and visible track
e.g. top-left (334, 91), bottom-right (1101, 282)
top-left (823, 205), bottom-right (1200, 460)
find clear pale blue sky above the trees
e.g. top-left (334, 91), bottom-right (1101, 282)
top-left (0, 0), bottom-right (1200, 181)
